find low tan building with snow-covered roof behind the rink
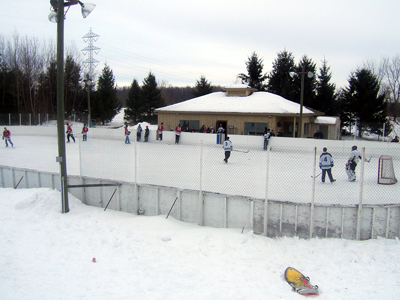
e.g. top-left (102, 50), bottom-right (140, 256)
top-left (155, 84), bottom-right (340, 139)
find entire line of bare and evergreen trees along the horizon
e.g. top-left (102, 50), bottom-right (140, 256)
top-left (0, 35), bottom-right (400, 133)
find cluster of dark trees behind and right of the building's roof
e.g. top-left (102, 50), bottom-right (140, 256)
top-left (238, 50), bottom-right (394, 136)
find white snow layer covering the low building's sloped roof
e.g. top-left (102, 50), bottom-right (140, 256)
top-left (156, 92), bottom-right (315, 115)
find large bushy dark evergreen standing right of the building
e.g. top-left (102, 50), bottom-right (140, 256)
top-left (345, 69), bottom-right (391, 137)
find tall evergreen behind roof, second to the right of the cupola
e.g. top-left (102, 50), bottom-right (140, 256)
top-left (267, 49), bottom-right (296, 101)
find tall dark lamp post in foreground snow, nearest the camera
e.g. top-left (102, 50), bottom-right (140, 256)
top-left (49, 0), bottom-right (95, 213)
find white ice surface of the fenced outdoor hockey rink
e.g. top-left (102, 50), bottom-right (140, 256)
top-left (0, 135), bottom-right (400, 205)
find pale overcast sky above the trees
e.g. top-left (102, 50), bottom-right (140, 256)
top-left (0, 0), bottom-right (400, 87)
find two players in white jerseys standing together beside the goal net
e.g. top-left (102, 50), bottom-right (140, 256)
top-left (319, 146), bottom-right (365, 182)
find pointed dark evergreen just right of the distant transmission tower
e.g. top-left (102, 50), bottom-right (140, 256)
top-left (91, 64), bottom-right (121, 124)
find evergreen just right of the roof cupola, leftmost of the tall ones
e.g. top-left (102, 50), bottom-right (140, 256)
top-left (238, 52), bottom-right (267, 91)
